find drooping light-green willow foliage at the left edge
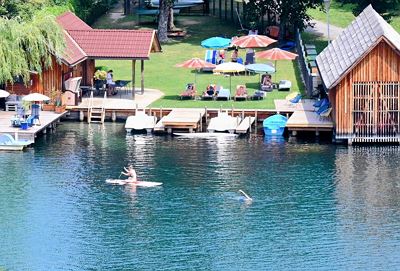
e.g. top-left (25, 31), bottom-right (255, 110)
top-left (0, 15), bottom-right (65, 83)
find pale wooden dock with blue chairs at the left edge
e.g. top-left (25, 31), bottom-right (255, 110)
top-left (0, 111), bottom-right (67, 143)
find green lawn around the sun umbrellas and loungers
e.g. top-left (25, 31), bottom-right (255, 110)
top-left (95, 16), bottom-right (304, 109)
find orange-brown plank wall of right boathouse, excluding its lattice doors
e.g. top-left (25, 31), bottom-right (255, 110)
top-left (329, 39), bottom-right (400, 138)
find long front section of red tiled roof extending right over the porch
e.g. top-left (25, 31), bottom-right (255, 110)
top-left (68, 29), bottom-right (160, 59)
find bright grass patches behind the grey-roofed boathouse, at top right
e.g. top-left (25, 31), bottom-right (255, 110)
top-left (308, 0), bottom-right (400, 32)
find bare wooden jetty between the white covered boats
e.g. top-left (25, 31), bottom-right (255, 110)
top-left (154, 108), bottom-right (206, 133)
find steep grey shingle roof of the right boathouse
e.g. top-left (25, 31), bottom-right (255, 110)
top-left (317, 5), bottom-right (400, 89)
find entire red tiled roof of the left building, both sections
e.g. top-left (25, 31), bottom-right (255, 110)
top-left (57, 11), bottom-right (161, 66)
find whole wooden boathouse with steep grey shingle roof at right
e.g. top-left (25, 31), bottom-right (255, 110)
top-left (317, 5), bottom-right (400, 144)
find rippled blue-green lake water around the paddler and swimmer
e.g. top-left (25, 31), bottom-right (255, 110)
top-left (0, 122), bottom-right (400, 271)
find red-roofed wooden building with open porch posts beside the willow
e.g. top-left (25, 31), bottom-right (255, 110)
top-left (6, 12), bottom-right (161, 100)
